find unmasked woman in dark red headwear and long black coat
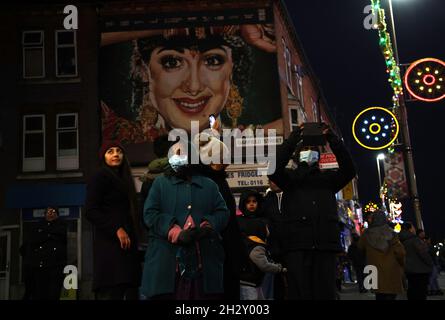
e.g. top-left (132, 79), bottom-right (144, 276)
top-left (85, 141), bottom-right (141, 300)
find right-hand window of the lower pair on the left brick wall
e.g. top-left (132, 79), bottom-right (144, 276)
top-left (56, 113), bottom-right (79, 170)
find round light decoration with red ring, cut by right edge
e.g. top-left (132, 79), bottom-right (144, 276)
top-left (405, 58), bottom-right (445, 102)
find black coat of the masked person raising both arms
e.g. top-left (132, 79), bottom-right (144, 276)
top-left (269, 130), bottom-right (356, 251)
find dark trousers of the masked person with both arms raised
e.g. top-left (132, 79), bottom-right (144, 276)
top-left (285, 251), bottom-right (336, 300)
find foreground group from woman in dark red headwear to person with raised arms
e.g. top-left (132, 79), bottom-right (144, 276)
top-left (80, 122), bottom-right (356, 300)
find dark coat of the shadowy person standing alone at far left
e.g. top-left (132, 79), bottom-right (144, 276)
top-left (23, 219), bottom-right (67, 268)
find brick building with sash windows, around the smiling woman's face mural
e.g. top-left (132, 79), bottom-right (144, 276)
top-left (0, 0), bottom-right (356, 299)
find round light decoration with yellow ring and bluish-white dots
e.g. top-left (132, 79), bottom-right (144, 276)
top-left (352, 107), bottom-right (399, 150)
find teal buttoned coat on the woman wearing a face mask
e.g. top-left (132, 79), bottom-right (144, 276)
top-left (141, 176), bottom-right (229, 297)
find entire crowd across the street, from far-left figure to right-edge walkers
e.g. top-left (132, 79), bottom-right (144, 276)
top-left (23, 126), bottom-right (443, 300)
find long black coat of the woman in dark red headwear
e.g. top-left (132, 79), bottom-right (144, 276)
top-left (85, 168), bottom-right (141, 290)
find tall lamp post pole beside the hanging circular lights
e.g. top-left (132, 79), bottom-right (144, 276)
top-left (388, 0), bottom-right (424, 229)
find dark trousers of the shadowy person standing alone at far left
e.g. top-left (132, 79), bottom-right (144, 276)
top-left (28, 266), bottom-right (64, 300)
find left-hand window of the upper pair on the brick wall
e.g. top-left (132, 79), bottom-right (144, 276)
top-left (22, 31), bottom-right (45, 79)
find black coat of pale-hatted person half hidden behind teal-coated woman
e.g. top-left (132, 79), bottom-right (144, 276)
top-left (198, 165), bottom-right (245, 300)
